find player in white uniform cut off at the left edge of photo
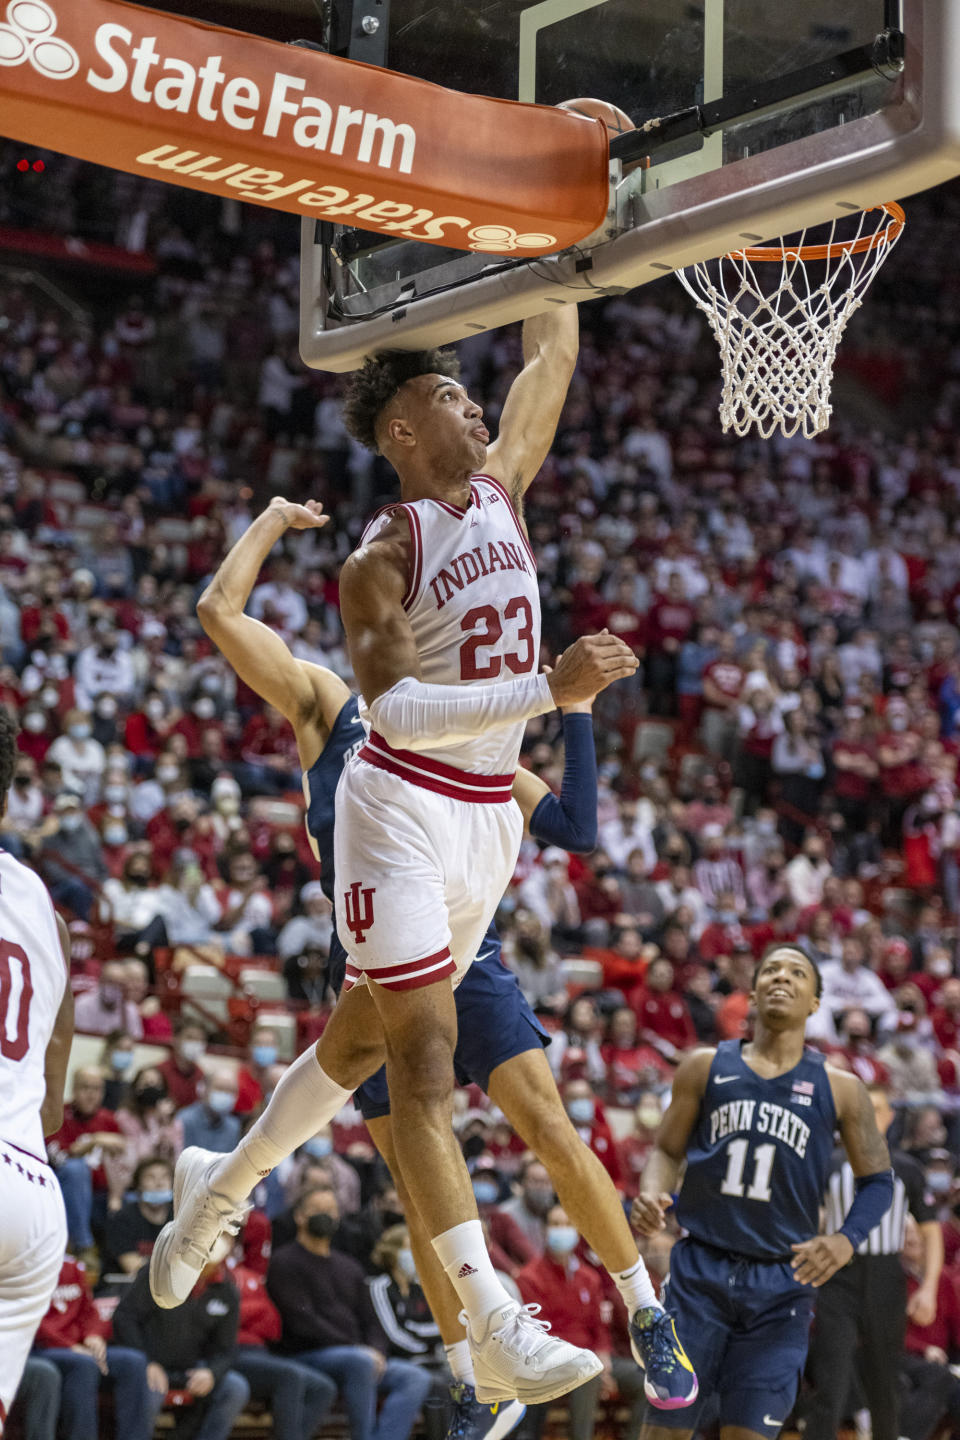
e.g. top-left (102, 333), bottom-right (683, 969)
top-left (0, 706), bottom-right (73, 1436)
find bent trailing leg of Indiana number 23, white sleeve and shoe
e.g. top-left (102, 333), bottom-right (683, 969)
top-left (150, 988), bottom-right (384, 1309)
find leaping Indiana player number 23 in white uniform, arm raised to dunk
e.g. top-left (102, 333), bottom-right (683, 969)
top-left (151, 305), bottom-right (636, 1403)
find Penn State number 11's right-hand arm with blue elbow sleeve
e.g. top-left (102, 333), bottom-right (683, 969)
top-left (792, 1068), bottom-right (894, 1289)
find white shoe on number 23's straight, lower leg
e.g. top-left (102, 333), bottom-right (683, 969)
top-left (461, 1300), bottom-right (603, 1405)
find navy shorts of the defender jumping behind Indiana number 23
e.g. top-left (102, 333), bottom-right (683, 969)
top-left (354, 945), bottom-right (550, 1120)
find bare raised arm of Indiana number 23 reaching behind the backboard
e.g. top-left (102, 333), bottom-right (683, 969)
top-left (484, 304), bottom-right (580, 510)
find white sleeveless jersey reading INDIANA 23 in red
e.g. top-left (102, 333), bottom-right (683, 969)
top-left (360, 475), bottom-right (540, 776)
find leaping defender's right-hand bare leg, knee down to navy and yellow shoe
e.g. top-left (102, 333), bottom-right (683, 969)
top-left (488, 1044), bottom-right (697, 1405)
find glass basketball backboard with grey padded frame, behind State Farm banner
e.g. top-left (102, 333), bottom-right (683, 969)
top-left (301, 0), bottom-right (960, 369)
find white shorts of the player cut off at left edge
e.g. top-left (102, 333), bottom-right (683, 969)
top-left (0, 1140), bottom-right (66, 1434)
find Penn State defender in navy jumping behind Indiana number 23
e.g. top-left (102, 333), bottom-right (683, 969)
top-left (179, 498), bottom-right (697, 1440)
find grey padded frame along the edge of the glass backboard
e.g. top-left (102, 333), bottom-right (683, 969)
top-left (301, 0), bottom-right (960, 372)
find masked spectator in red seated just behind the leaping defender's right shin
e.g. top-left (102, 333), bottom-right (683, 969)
top-left (517, 1205), bottom-right (616, 1440)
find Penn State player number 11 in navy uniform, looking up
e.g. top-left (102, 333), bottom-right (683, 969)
top-left (630, 945), bottom-right (892, 1440)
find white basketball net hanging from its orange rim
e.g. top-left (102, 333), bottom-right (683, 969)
top-left (676, 204), bottom-right (904, 439)
